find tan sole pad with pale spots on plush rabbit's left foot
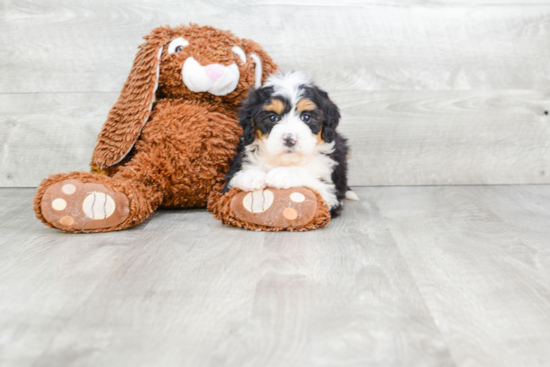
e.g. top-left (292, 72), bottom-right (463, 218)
top-left (41, 180), bottom-right (130, 230)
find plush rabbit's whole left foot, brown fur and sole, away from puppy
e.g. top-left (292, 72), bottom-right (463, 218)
top-left (33, 171), bottom-right (163, 233)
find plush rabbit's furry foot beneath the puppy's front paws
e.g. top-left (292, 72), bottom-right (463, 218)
top-left (208, 187), bottom-right (330, 231)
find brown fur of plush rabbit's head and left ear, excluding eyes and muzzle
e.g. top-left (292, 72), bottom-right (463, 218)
top-left (91, 24), bottom-right (277, 169)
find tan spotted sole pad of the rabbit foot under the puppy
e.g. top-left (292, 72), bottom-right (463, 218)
top-left (231, 187), bottom-right (317, 228)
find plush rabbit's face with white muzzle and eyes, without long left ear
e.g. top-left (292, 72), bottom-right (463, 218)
top-left (157, 25), bottom-right (274, 104)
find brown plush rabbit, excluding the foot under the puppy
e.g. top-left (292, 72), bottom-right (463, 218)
top-left (34, 25), bottom-right (277, 232)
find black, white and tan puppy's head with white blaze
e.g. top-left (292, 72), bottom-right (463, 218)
top-left (240, 72), bottom-right (340, 157)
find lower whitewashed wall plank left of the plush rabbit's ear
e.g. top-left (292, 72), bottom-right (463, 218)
top-left (0, 93), bottom-right (118, 187)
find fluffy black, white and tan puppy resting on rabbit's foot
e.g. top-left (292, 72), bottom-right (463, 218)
top-left (223, 72), bottom-right (357, 217)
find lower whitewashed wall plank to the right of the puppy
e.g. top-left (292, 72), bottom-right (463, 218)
top-left (334, 91), bottom-right (550, 186)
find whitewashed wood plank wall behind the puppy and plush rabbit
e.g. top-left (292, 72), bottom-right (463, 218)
top-left (0, 0), bottom-right (550, 187)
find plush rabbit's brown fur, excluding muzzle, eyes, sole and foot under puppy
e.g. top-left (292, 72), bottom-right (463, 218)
top-left (34, 24), bottom-right (277, 232)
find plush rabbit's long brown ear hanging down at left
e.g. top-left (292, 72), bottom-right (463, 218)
top-left (92, 29), bottom-right (167, 169)
